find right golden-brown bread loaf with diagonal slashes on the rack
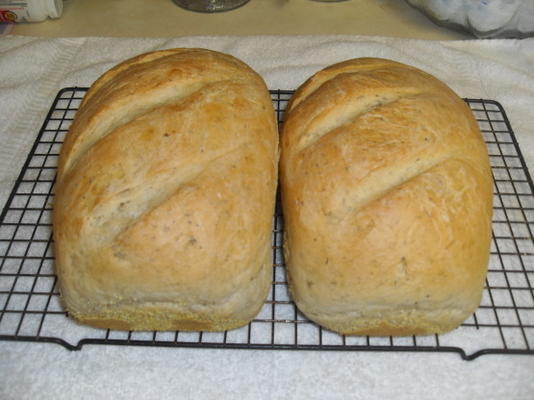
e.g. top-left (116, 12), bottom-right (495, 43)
top-left (280, 58), bottom-right (492, 336)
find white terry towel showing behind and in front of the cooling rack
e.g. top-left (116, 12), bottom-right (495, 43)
top-left (0, 36), bottom-right (534, 400)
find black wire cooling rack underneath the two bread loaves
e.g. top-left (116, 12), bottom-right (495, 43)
top-left (0, 88), bottom-right (534, 360)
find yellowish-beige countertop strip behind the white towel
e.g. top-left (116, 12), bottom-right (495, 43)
top-left (12, 0), bottom-right (471, 40)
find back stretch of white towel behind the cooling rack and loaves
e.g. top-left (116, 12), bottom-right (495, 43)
top-left (0, 36), bottom-right (534, 204)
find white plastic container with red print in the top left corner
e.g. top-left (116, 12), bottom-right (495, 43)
top-left (0, 0), bottom-right (63, 22)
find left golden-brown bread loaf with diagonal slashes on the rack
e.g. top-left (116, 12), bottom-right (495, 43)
top-left (53, 49), bottom-right (278, 331)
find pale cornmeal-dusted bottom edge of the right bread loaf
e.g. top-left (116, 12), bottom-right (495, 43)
top-left (307, 309), bottom-right (474, 336)
